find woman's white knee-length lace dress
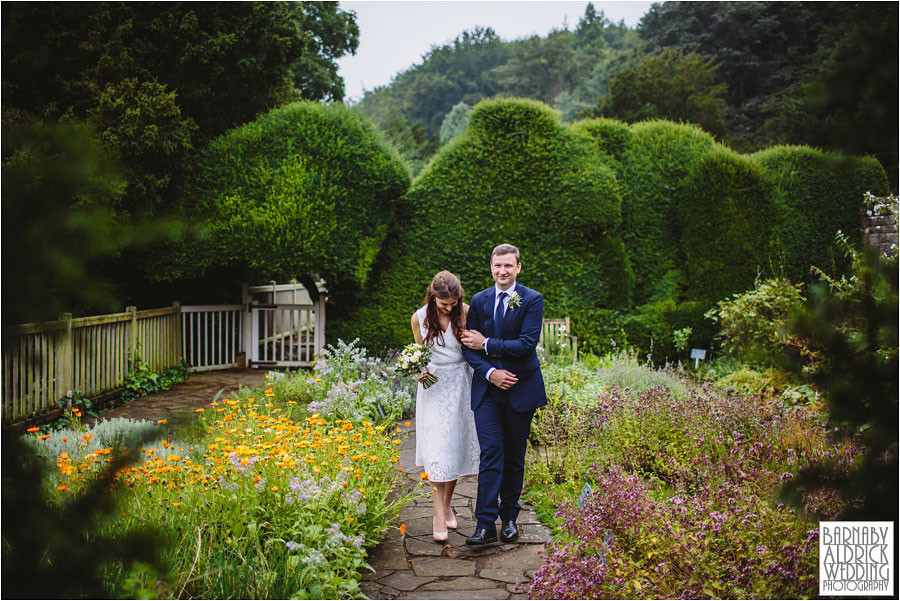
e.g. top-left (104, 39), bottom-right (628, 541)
top-left (416, 307), bottom-right (481, 482)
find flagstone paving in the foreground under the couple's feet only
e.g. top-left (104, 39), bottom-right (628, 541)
top-left (360, 419), bottom-right (550, 599)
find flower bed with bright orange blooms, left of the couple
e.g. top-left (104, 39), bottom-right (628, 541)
top-left (25, 373), bottom-right (418, 598)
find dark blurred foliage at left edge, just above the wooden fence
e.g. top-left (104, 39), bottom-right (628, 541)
top-left (2, 123), bottom-right (125, 325)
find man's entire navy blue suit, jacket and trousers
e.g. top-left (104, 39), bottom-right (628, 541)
top-left (462, 284), bottom-right (547, 529)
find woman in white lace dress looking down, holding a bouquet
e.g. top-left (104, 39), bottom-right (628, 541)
top-left (411, 271), bottom-right (480, 542)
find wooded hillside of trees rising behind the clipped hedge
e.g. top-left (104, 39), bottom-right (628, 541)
top-left (355, 2), bottom-right (898, 189)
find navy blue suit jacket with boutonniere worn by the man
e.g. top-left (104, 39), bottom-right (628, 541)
top-left (462, 283), bottom-right (547, 411)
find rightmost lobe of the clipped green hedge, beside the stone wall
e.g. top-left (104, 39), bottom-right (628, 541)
top-left (752, 146), bottom-right (888, 282)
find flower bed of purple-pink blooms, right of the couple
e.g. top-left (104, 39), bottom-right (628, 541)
top-left (526, 358), bottom-right (858, 599)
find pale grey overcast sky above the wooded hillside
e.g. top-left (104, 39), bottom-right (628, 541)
top-left (338, 0), bottom-right (652, 102)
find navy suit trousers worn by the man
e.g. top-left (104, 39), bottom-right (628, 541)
top-left (475, 385), bottom-right (535, 529)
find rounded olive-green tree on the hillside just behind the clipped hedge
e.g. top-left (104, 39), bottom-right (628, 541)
top-left (599, 48), bottom-right (728, 139)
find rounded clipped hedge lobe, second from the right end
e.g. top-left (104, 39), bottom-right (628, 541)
top-left (678, 149), bottom-right (776, 303)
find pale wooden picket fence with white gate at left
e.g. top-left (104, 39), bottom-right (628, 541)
top-left (0, 292), bottom-right (325, 424)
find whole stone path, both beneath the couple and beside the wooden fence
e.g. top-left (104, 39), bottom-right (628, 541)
top-left (100, 369), bottom-right (550, 599)
